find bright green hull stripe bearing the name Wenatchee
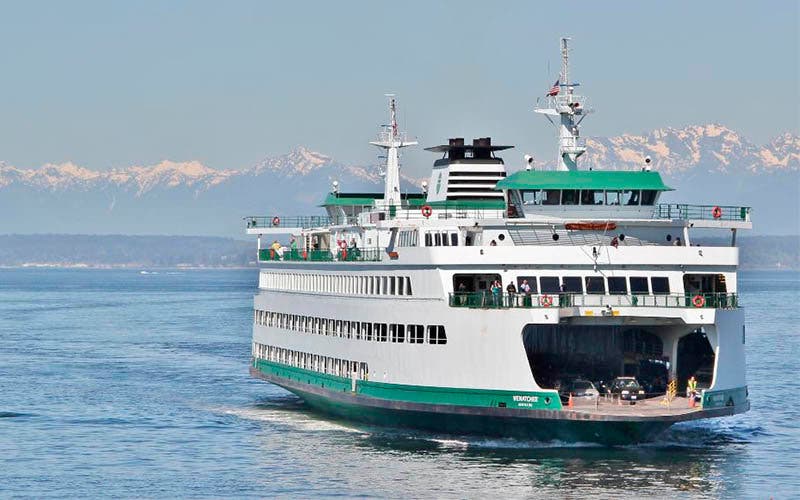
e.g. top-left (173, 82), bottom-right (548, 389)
top-left (253, 359), bottom-right (562, 410)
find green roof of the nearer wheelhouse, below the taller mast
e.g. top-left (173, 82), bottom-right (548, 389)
top-left (495, 170), bottom-right (672, 191)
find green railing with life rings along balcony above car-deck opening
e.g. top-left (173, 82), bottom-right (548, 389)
top-left (449, 292), bottom-right (739, 309)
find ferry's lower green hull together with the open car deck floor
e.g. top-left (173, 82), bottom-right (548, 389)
top-left (250, 359), bottom-right (749, 445)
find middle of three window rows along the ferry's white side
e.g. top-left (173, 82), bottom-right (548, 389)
top-left (255, 309), bottom-right (447, 344)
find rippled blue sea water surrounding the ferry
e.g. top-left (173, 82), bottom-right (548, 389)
top-left (0, 269), bottom-right (800, 498)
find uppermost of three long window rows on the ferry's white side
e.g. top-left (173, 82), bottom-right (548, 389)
top-left (261, 273), bottom-right (412, 295)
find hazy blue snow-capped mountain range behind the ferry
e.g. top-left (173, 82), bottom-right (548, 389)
top-left (0, 124), bottom-right (800, 236)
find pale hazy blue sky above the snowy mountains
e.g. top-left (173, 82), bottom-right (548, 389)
top-left (0, 0), bottom-right (800, 177)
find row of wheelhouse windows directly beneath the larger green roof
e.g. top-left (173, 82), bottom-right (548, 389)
top-left (520, 189), bottom-right (658, 206)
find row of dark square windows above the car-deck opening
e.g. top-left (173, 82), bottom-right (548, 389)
top-left (517, 276), bottom-right (670, 295)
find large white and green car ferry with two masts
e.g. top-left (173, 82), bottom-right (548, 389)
top-left (245, 38), bottom-right (752, 445)
